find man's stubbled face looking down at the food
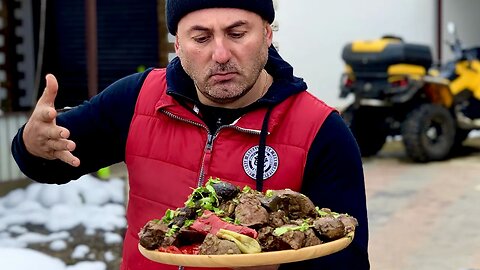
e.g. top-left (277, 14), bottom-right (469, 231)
top-left (175, 8), bottom-right (272, 106)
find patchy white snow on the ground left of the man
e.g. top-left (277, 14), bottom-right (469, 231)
top-left (0, 175), bottom-right (126, 270)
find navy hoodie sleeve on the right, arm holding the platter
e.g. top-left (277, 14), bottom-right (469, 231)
top-left (280, 112), bottom-right (370, 270)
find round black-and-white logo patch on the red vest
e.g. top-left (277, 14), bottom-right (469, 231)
top-left (243, 145), bottom-right (278, 180)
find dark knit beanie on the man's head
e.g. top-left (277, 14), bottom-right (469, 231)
top-left (165, 0), bottom-right (275, 35)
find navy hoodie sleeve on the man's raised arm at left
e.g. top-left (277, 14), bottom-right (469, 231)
top-left (11, 70), bottom-right (150, 184)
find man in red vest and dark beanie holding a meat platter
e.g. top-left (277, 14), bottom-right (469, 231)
top-left (12, 0), bottom-right (369, 270)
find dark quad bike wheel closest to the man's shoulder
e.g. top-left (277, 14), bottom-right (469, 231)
top-left (342, 105), bottom-right (387, 157)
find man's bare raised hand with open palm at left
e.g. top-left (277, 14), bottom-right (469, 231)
top-left (23, 74), bottom-right (80, 167)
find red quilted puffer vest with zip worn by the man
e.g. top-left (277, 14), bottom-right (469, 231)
top-left (122, 69), bottom-right (333, 270)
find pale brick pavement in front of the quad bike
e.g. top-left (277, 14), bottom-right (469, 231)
top-left (364, 139), bottom-right (480, 270)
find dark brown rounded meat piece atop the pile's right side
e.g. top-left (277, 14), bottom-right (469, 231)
top-left (264, 189), bottom-right (316, 219)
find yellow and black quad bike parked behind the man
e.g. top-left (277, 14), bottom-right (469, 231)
top-left (340, 25), bottom-right (480, 162)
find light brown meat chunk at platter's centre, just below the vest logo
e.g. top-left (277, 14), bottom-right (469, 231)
top-left (235, 193), bottom-right (268, 226)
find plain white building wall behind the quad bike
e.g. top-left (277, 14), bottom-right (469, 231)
top-left (274, 0), bottom-right (480, 107)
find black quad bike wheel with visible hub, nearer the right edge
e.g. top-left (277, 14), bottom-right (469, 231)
top-left (402, 104), bottom-right (456, 162)
